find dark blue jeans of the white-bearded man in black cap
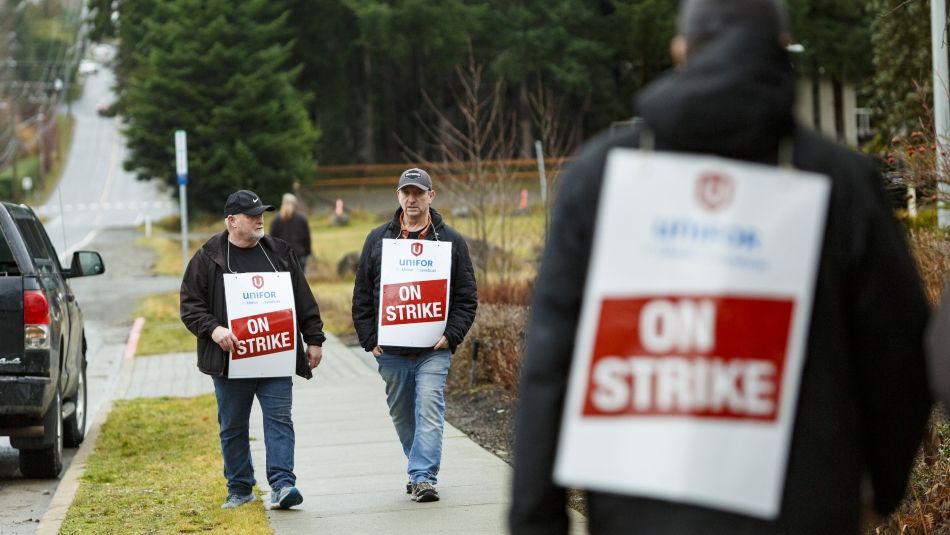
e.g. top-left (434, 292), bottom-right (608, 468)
top-left (212, 376), bottom-right (297, 496)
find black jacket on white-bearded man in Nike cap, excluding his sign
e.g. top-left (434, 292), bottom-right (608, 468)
top-left (180, 232), bottom-right (326, 379)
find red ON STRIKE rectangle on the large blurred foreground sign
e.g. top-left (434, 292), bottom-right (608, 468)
top-left (583, 295), bottom-right (794, 421)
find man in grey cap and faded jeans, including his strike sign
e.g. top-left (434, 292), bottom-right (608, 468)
top-left (353, 168), bottom-right (478, 502)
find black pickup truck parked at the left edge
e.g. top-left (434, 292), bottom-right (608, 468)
top-left (0, 202), bottom-right (105, 478)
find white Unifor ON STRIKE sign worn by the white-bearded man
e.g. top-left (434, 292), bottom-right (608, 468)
top-left (224, 272), bottom-right (298, 379)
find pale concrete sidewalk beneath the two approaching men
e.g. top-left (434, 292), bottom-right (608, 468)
top-left (120, 336), bottom-right (586, 535)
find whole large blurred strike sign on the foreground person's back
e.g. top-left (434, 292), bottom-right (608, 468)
top-left (555, 149), bottom-right (830, 518)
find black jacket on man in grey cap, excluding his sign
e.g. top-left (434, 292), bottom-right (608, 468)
top-left (353, 208), bottom-right (478, 355)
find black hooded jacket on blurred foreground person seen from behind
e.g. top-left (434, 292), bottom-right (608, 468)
top-left (510, 27), bottom-right (930, 535)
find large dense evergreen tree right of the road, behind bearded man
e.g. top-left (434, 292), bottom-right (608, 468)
top-left (125, 0), bottom-right (316, 212)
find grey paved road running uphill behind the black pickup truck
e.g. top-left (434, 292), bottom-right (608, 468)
top-left (0, 48), bottom-right (178, 535)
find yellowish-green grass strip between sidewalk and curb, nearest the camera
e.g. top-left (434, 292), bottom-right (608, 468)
top-left (60, 394), bottom-right (273, 535)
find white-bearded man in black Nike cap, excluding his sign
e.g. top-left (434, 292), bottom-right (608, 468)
top-left (181, 190), bottom-right (326, 509)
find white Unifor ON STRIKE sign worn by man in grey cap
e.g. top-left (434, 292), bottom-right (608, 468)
top-left (378, 239), bottom-right (452, 347)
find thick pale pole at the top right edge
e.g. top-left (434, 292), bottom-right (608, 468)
top-left (930, 0), bottom-right (950, 229)
